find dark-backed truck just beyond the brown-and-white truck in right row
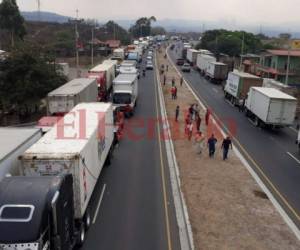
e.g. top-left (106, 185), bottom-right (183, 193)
top-left (205, 62), bottom-right (228, 83)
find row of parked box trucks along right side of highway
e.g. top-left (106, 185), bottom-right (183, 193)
top-left (182, 45), bottom-right (300, 131)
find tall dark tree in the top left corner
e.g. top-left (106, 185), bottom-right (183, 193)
top-left (0, 0), bottom-right (26, 47)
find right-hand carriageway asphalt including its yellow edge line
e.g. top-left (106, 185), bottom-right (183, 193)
top-left (169, 44), bottom-right (300, 228)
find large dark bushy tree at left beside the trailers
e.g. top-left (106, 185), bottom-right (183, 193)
top-left (0, 45), bottom-right (66, 114)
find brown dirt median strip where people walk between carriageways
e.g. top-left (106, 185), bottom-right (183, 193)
top-left (157, 47), bottom-right (300, 250)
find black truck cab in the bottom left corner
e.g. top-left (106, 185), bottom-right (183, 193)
top-left (0, 175), bottom-right (81, 250)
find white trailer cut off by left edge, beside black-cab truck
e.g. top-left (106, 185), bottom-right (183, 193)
top-left (0, 127), bottom-right (42, 181)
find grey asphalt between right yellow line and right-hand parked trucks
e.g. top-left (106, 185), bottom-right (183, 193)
top-left (169, 47), bottom-right (300, 225)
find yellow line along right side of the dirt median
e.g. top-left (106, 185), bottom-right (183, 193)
top-left (186, 68), bottom-right (300, 220)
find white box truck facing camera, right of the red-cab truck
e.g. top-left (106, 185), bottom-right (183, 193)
top-left (112, 74), bottom-right (138, 117)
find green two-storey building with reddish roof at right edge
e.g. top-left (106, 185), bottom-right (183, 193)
top-left (256, 50), bottom-right (300, 85)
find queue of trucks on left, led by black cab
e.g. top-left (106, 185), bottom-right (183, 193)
top-left (0, 36), bottom-right (151, 250)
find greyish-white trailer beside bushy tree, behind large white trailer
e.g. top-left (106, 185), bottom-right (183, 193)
top-left (47, 78), bottom-right (98, 116)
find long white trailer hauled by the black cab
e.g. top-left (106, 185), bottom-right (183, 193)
top-left (20, 103), bottom-right (114, 221)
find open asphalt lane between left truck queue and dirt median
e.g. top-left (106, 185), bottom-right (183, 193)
top-left (82, 50), bottom-right (180, 250)
